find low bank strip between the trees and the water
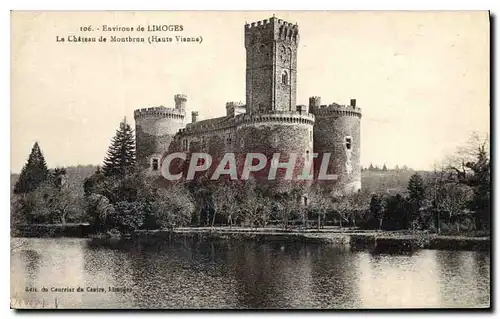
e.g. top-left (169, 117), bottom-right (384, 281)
top-left (12, 224), bottom-right (491, 252)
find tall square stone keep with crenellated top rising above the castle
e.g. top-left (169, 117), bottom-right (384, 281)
top-left (245, 17), bottom-right (299, 114)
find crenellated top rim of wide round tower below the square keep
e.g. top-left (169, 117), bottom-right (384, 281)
top-left (235, 111), bottom-right (314, 125)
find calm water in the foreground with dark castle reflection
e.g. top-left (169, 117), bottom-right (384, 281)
top-left (11, 238), bottom-right (490, 309)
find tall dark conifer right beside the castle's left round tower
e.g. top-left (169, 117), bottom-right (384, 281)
top-left (102, 118), bottom-right (135, 176)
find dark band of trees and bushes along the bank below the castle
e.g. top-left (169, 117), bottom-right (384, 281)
top-left (11, 134), bottom-right (491, 233)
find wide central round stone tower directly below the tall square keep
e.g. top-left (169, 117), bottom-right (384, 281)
top-left (235, 112), bottom-right (314, 194)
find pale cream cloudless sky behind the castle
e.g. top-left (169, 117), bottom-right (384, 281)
top-left (11, 11), bottom-right (490, 173)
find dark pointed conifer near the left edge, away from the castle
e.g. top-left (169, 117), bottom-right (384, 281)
top-left (14, 142), bottom-right (49, 194)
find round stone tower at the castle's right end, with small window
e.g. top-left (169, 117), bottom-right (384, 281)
top-left (309, 97), bottom-right (361, 193)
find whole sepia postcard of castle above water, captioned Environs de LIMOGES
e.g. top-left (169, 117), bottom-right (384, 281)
top-left (10, 10), bottom-right (493, 310)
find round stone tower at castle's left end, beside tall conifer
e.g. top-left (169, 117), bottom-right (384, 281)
top-left (134, 94), bottom-right (187, 173)
